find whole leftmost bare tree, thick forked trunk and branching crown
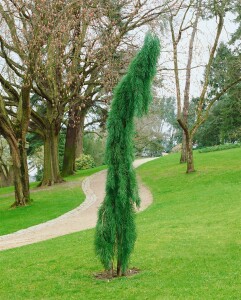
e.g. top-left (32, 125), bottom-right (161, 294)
top-left (0, 0), bottom-right (48, 206)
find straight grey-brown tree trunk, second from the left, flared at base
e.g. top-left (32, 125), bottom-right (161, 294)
top-left (40, 126), bottom-right (63, 186)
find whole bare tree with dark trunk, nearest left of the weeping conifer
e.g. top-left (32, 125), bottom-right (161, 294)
top-left (60, 1), bottom-right (175, 175)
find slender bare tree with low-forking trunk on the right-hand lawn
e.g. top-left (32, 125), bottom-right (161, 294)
top-left (169, 0), bottom-right (241, 173)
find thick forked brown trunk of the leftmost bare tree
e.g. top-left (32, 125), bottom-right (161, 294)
top-left (0, 67), bottom-right (32, 207)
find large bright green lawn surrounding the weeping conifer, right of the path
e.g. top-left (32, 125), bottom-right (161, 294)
top-left (0, 149), bottom-right (241, 300)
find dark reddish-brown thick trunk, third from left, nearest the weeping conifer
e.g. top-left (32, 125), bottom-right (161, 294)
top-left (62, 107), bottom-right (86, 176)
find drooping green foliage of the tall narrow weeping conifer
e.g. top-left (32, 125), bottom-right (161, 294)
top-left (95, 33), bottom-right (160, 276)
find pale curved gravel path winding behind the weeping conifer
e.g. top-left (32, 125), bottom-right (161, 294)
top-left (0, 158), bottom-right (155, 251)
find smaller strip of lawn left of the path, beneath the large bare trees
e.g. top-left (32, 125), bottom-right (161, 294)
top-left (0, 167), bottom-right (104, 236)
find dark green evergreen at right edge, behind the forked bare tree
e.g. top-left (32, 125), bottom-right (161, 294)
top-left (195, 43), bottom-right (241, 146)
